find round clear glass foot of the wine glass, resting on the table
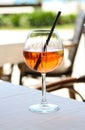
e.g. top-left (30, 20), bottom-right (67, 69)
top-left (29, 104), bottom-right (59, 113)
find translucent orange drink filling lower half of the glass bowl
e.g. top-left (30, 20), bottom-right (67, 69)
top-left (23, 50), bottom-right (64, 73)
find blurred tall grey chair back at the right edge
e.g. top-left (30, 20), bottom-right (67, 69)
top-left (69, 11), bottom-right (85, 70)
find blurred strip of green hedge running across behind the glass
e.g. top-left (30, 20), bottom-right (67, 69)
top-left (0, 10), bottom-right (76, 28)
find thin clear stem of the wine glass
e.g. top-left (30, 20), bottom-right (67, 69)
top-left (41, 73), bottom-right (47, 104)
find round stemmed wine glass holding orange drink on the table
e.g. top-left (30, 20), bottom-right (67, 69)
top-left (23, 29), bottom-right (64, 113)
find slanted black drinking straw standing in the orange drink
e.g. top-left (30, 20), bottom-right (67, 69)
top-left (34, 11), bottom-right (61, 70)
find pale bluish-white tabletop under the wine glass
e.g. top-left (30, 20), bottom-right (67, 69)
top-left (0, 80), bottom-right (85, 130)
